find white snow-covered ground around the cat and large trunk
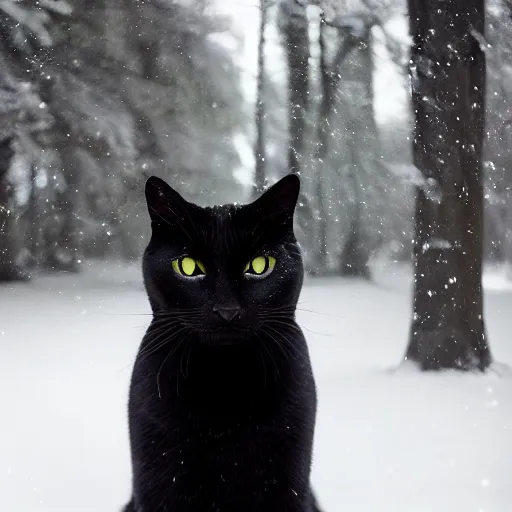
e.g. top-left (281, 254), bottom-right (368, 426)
top-left (0, 265), bottom-right (512, 512)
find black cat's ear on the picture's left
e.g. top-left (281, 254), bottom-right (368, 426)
top-left (145, 176), bottom-right (189, 224)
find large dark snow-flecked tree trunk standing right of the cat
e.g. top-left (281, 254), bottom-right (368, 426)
top-left (406, 0), bottom-right (491, 370)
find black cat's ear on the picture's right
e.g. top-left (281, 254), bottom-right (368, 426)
top-left (249, 174), bottom-right (300, 221)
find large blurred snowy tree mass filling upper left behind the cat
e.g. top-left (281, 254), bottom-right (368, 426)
top-left (0, 0), bottom-right (246, 270)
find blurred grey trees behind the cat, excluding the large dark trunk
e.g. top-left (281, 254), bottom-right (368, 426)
top-left (0, 0), bottom-right (512, 280)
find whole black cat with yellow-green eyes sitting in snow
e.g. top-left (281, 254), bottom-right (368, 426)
top-left (125, 175), bottom-right (317, 512)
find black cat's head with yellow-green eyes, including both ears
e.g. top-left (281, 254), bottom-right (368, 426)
top-left (143, 175), bottom-right (304, 343)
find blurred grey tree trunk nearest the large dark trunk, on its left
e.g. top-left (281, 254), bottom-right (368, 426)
top-left (320, 14), bottom-right (382, 278)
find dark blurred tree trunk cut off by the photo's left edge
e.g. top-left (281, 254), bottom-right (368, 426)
top-left (0, 138), bottom-right (28, 282)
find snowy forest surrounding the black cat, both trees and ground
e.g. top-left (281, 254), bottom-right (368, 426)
top-left (0, 0), bottom-right (512, 512)
